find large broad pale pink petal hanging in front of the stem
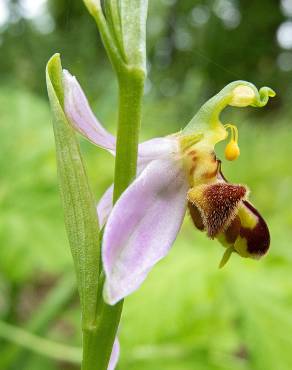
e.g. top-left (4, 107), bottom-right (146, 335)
top-left (102, 159), bottom-right (188, 304)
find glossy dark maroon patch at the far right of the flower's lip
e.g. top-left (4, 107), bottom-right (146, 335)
top-left (240, 201), bottom-right (270, 257)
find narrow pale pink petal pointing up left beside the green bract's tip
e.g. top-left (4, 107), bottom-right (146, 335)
top-left (63, 70), bottom-right (116, 151)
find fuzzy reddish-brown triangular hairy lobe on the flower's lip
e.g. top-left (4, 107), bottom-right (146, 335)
top-left (188, 182), bottom-right (247, 238)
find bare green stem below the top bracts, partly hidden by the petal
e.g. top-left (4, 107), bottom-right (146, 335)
top-left (82, 68), bottom-right (145, 370)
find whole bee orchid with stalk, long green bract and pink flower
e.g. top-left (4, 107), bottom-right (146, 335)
top-left (47, 0), bottom-right (275, 370)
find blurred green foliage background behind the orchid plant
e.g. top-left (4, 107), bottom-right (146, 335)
top-left (0, 0), bottom-right (292, 370)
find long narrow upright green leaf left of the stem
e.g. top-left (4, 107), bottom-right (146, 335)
top-left (46, 54), bottom-right (100, 327)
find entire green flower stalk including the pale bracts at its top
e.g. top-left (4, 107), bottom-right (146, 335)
top-left (78, 0), bottom-right (148, 370)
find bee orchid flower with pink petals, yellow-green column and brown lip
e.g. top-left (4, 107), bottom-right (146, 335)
top-left (63, 71), bottom-right (275, 304)
